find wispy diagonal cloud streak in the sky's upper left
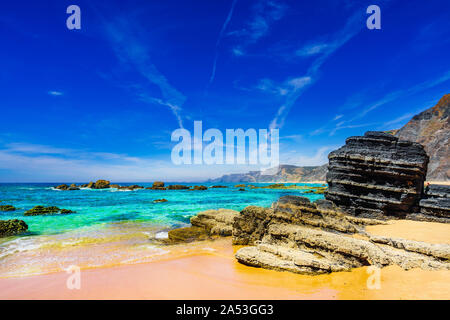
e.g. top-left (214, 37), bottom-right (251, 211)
top-left (104, 18), bottom-right (186, 128)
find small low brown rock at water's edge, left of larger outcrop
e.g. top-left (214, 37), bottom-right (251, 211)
top-left (169, 209), bottom-right (239, 243)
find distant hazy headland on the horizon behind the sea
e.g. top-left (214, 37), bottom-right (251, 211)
top-left (209, 165), bottom-right (327, 183)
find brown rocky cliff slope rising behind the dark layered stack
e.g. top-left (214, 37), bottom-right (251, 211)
top-left (394, 94), bottom-right (450, 181)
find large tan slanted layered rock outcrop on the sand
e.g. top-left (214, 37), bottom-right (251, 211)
top-left (233, 196), bottom-right (450, 274)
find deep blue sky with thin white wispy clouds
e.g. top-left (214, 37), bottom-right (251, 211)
top-left (0, 0), bottom-right (450, 182)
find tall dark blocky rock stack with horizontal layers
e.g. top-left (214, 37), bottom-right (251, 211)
top-left (325, 131), bottom-right (428, 219)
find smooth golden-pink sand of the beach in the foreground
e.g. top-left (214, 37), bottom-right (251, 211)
top-left (0, 221), bottom-right (450, 299)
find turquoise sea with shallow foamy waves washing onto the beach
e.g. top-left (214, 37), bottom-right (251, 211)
top-left (0, 182), bottom-right (323, 277)
